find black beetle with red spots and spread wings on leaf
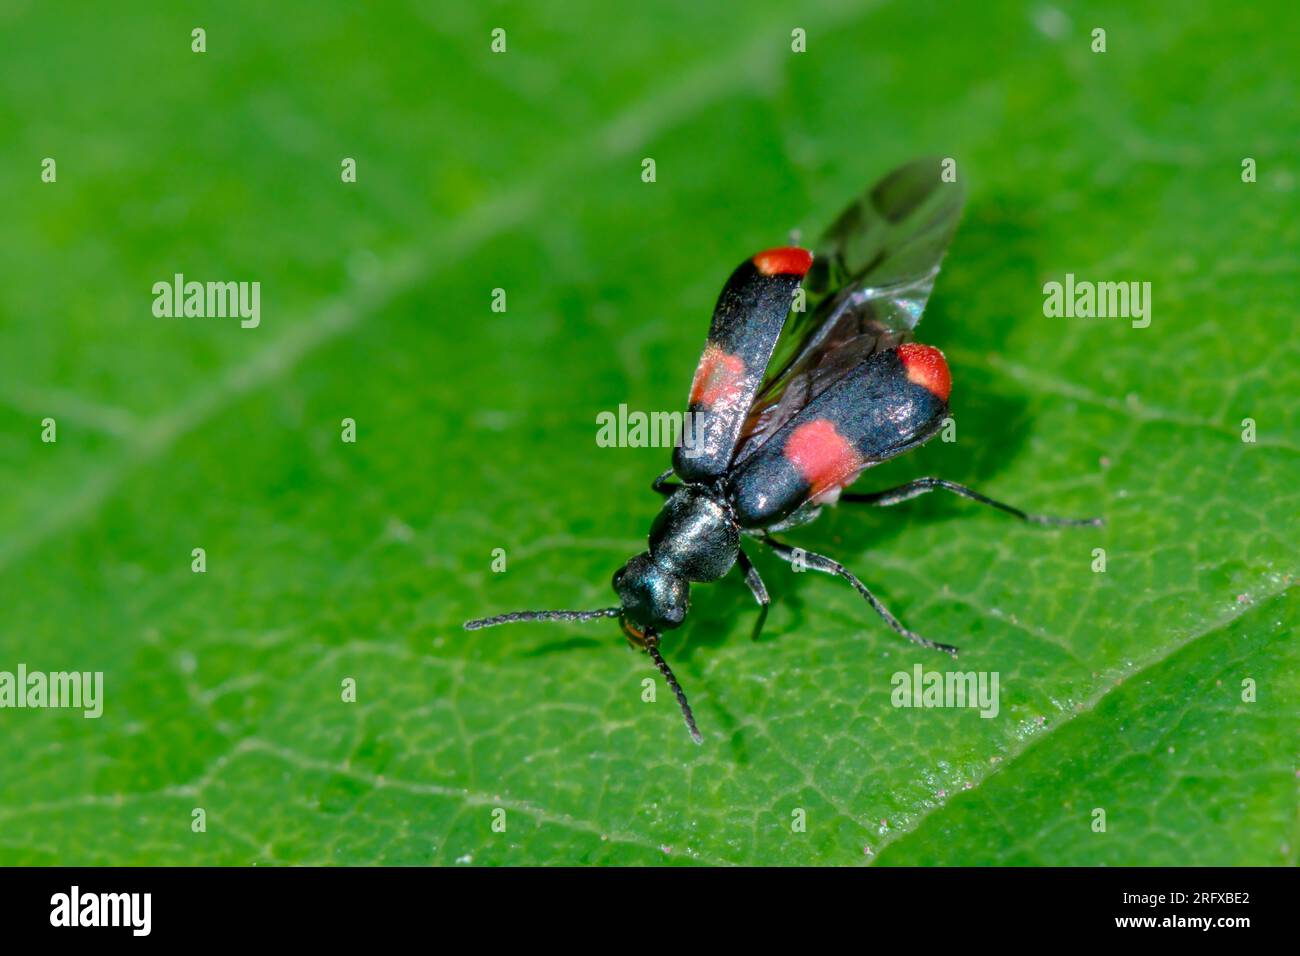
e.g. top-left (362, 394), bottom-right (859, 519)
top-left (465, 159), bottom-right (1104, 744)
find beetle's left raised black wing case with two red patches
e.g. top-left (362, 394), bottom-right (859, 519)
top-left (672, 247), bottom-right (813, 481)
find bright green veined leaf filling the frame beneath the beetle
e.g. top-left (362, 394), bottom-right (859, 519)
top-left (0, 0), bottom-right (1300, 865)
